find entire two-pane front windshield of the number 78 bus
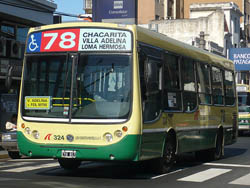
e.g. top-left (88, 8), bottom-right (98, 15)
top-left (22, 54), bottom-right (131, 121)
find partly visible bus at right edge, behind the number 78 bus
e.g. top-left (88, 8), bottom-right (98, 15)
top-left (236, 84), bottom-right (250, 135)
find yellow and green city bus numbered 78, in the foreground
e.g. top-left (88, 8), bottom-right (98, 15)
top-left (17, 22), bottom-right (238, 173)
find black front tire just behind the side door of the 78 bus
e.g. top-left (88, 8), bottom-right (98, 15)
top-left (151, 136), bottom-right (176, 174)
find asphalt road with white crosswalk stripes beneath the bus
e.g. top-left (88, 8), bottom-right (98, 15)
top-left (0, 135), bottom-right (250, 188)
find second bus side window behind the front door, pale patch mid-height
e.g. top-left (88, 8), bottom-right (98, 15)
top-left (181, 58), bottom-right (197, 112)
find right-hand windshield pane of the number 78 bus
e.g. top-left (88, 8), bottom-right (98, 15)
top-left (72, 55), bottom-right (131, 119)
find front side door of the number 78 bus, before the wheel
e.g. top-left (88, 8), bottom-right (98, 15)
top-left (140, 51), bottom-right (166, 159)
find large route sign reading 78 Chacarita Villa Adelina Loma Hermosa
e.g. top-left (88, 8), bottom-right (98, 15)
top-left (27, 28), bottom-right (132, 53)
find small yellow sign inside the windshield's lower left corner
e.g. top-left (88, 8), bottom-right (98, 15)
top-left (25, 96), bottom-right (51, 110)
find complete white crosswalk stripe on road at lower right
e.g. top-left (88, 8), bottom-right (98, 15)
top-left (178, 168), bottom-right (232, 182)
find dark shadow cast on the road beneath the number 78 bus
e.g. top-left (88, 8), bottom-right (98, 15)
top-left (38, 147), bottom-right (247, 180)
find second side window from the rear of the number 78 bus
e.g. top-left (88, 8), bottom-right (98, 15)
top-left (212, 67), bottom-right (224, 105)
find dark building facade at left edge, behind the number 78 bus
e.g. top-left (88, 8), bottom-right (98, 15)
top-left (0, 0), bottom-right (57, 132)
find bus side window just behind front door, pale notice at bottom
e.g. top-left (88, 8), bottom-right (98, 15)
top-left (163, 53), bottom-right (182, 111)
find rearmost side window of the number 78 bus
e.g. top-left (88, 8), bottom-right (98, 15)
top-left (224, 71), bottom-right (235, 105)
